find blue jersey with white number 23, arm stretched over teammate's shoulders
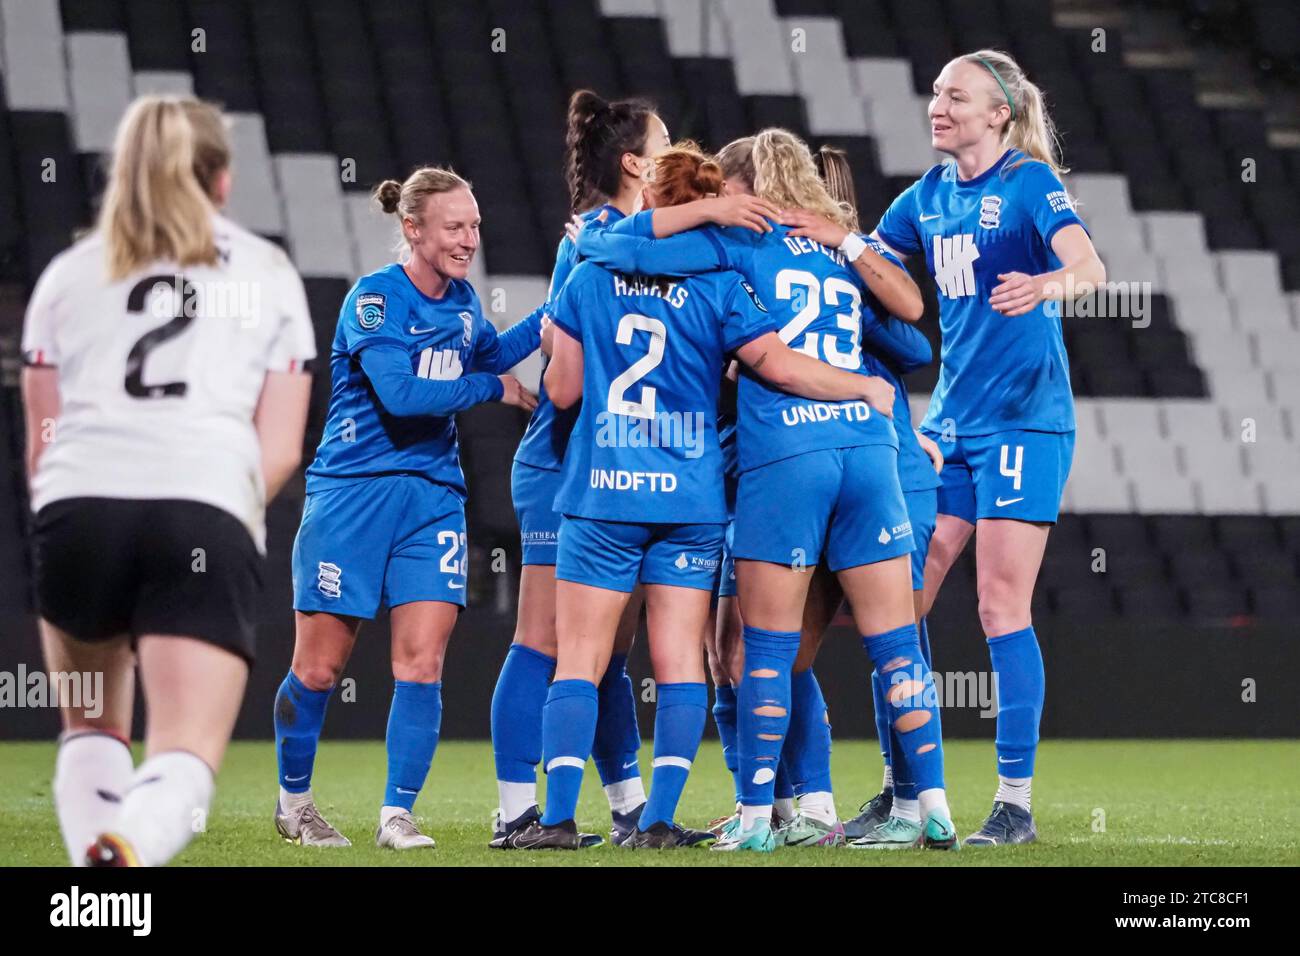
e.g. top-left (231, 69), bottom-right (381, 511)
top-left (579, 209), bottom-right (898, 472)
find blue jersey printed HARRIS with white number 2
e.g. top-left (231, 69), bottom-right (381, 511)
top-left (553, 263), bottom-right (776, 524)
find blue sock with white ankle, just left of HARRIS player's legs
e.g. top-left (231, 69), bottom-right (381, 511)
top-left (491, 644), bottom-right (555, 822)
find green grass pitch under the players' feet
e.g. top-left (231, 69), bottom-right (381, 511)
top-left (0, 740), bottom-right (1300, 866)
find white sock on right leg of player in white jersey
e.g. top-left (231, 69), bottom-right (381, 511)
top-left (112, 750), bottom-right (212, 866)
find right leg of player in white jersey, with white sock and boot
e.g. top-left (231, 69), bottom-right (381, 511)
top-left (87, 635), bottom-right (248, 866)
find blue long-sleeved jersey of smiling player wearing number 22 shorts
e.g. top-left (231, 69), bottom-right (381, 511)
top-left (307, 263), bottom-right (537, 498)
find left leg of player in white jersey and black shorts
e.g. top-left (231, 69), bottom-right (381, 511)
top-left (40, 620), bottom-right (135, 866)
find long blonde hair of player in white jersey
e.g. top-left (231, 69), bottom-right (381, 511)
top-left (99, 96), bottom-right (230, 281)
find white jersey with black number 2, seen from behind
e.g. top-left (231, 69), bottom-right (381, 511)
top-left (22, 216), bottom-right (316, 550)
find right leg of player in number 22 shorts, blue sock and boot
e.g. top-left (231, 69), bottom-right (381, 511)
top-left (374, 601), bottom-right (460, 849)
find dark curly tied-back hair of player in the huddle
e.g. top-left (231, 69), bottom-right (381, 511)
top-left (564, 90), bottom-right (654, 212)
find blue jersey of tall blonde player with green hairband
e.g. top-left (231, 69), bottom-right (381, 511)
top-left (876, 150), bottom-right (1083, 434)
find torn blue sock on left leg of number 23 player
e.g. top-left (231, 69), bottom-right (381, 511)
top-left (736, 624), bottom-right (800, 823)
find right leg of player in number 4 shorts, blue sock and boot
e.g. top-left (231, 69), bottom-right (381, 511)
top-left (967, 518), bottom-right (1052, 845)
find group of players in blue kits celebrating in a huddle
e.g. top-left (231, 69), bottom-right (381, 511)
top-left (22, 51), bottom-right (1104, 864)
